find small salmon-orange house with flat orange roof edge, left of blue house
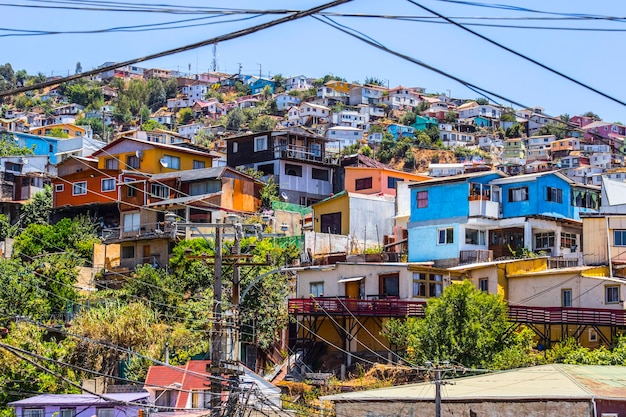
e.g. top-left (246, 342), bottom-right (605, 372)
top-left (344, 167), bottom-right (430, 196)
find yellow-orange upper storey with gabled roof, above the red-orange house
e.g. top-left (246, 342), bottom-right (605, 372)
top-left (93, 137), bottom-right (215, 174)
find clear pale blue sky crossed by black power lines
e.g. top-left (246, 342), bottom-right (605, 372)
top-left (0, 0), bottom-right (626, 122)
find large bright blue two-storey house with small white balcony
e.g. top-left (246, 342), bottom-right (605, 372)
top-left (408, 171), bottom-right (600, 266)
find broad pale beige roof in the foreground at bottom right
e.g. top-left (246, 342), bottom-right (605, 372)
top-left (322, 364), bottom-right (626, 402)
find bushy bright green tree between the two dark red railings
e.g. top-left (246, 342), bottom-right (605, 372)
top-left (383, 281), bottom-right (520, 367)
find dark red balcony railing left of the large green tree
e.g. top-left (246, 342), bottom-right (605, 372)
top-left (289, 297), bottom-right (426, 317)
